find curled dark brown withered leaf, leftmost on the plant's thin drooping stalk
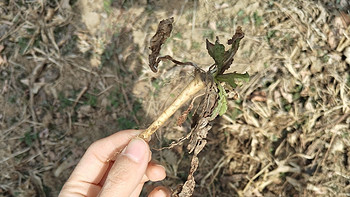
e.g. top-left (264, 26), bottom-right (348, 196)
top-left (149, 17), bottom-right (174, 72)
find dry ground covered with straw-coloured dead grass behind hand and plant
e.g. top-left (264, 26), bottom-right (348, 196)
top-left (0, 0), bottom-right (350, 196)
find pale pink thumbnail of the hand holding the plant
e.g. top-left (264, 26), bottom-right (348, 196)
top-left (123, 138), bottom-right (147, 163)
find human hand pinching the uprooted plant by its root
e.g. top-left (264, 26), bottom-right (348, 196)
top-left (59, 130), bottom-right (170, 197)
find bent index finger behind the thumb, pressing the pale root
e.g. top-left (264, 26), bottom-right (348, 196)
top-left (69, 130), bottom-right (141, 184)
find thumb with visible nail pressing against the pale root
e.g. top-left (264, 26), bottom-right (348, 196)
top-left (100, 138), bottom-right (150, 197)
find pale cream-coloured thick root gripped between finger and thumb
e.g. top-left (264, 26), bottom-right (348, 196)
top-left (139, 73), bottom-right (206, 140)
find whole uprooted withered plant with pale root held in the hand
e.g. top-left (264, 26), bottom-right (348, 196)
top-left (144, 18), bottom-right (249, 197)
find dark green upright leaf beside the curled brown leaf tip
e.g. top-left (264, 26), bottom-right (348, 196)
top-left (206, 38), bottom-right (225, 70)
